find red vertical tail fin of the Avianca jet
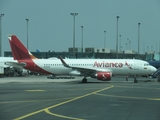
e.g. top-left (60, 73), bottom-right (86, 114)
top-left (8, 35), bottom-right (36, 60)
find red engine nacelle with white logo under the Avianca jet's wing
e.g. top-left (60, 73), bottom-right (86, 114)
top-left (95, 72), bottom-right (112, 81)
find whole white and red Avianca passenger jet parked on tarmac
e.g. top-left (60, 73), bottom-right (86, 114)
top-left (8, 35), bottom-right (156, 82)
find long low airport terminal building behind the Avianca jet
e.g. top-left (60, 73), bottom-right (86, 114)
top-left (4, 48), bottom-right (155, 60)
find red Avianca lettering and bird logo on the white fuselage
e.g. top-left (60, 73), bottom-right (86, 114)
top-left (93, 61), bottom-right (130, 68)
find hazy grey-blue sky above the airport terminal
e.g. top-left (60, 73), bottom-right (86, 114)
top-left (0, 0), bottom-right (160, 53)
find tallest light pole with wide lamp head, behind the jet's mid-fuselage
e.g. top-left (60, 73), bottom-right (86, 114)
top-left (70, 13), bottom-right (78, 57)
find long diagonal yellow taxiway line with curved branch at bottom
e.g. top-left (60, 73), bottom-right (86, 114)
top-left (14, 85), bottom-right (114, 120)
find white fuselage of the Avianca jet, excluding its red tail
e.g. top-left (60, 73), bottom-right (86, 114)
top-left (33, 59), bottom-right (156, 75)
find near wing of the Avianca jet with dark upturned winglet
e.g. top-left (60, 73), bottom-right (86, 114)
top-left (59, 57), bottom-right (112, 75)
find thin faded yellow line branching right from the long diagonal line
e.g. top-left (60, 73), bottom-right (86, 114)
top-left (95, 93), bottom-right (160, 100)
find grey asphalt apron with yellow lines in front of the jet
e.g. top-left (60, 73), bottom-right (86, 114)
top-left (0, 76), bottom-right (160, 120)
